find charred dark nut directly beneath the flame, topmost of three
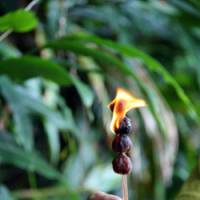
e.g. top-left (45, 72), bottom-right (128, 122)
top-left (115, 116), bottom-right (133, 134)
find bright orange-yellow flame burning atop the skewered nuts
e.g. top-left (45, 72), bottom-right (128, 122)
top-left (108, 88), bottom-right (146, 132)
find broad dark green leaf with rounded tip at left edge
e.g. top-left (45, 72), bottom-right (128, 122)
top-left (0, 56), bottom-right (71, 85)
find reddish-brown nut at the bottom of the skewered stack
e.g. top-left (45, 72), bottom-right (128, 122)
top-left (112, 154), bottom-right (132, 174)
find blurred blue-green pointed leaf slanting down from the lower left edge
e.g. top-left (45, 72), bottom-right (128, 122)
top-left (0, 132), bottom-right (61, 179)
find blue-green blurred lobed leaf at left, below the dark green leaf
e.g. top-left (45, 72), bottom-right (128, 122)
top-left (0, 76), bottom-right (76, 150)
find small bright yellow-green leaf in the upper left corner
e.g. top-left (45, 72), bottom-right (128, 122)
top-left (0, 9), bottom-right (38, 32)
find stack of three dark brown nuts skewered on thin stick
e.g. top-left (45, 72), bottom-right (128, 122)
top-left (112, 116), bottom-right (132, 174)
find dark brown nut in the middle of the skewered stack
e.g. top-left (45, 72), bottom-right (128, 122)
top-left (112, 134), bottom-right (132, 153)
